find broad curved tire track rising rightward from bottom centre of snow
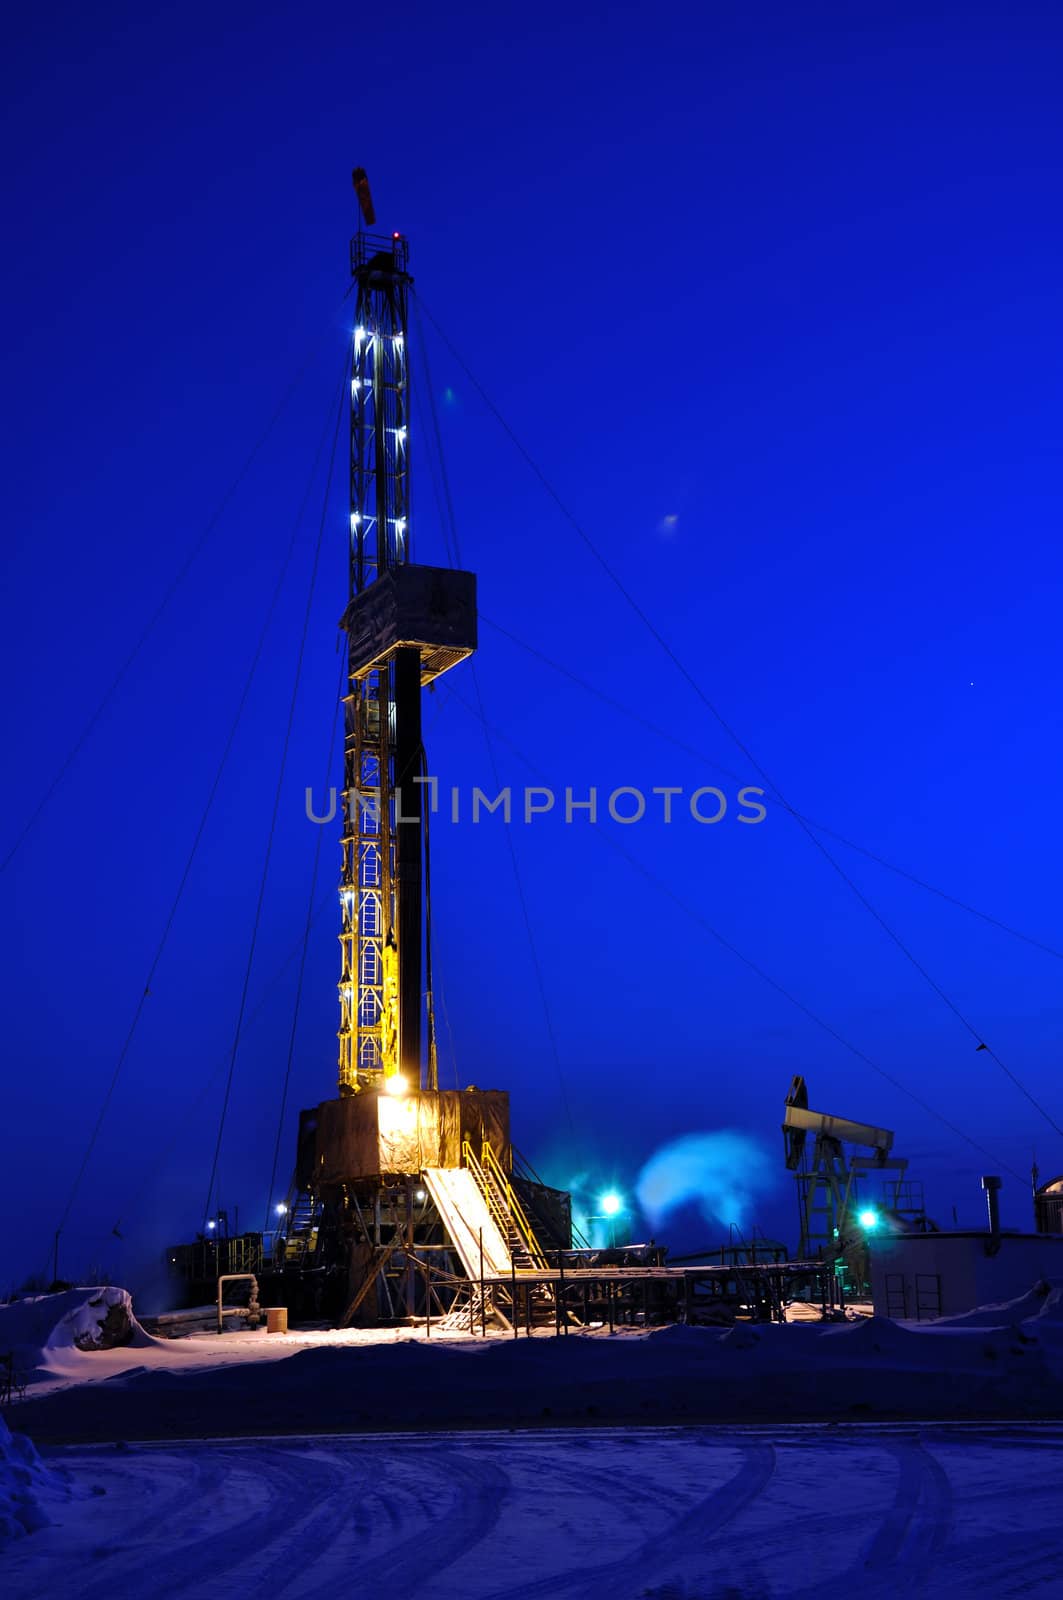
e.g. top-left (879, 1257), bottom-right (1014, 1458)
top-left (490, 1443), bottom-right (775, 1600)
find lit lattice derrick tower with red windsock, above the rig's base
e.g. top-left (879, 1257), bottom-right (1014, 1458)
top-left (339, 168), bottom-right (475, 1096)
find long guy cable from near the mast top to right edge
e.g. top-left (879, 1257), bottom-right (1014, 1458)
top-left (421, 301), bottom-right (1063, 1138)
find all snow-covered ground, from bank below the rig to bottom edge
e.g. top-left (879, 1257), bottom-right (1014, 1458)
top-left (0, 1285), bottom-right (1063, 1600)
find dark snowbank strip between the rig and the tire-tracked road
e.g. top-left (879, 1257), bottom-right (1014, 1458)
top-left (8, 1285), bottom-right (1063, 1445)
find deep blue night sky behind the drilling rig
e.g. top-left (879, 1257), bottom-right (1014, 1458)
top-left (0, 0), bottom-right (1063, 1288)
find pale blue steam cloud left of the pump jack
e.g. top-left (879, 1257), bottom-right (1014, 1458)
top-left (636, 1130), bottom-right (775, 1227)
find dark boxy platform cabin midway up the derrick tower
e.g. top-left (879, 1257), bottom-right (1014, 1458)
top-left (339, 563), bottom-right (475, 683)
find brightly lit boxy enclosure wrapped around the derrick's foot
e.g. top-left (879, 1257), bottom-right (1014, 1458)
top-left (308, 1088), bottom-right (512, 1186)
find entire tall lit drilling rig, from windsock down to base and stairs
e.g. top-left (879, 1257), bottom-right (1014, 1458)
top-left (170, 168), bottom-right (572, 1322)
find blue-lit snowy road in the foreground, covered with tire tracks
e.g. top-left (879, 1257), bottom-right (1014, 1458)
top-left (0, 1424), bottom-right (1063, 1600)
